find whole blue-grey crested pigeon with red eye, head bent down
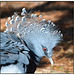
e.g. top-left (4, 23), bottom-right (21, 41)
top-left (0, 8), bottom-right (63, 73)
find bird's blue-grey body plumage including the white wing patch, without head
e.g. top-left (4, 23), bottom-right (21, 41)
top-left (0, 32), bottom-right (38, 73)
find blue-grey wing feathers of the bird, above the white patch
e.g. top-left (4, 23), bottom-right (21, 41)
top-left (0, 32), bottom-right (30, 73)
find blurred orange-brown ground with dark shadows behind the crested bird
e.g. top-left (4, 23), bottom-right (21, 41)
top-left (0, 1), bottom-right (74, 74)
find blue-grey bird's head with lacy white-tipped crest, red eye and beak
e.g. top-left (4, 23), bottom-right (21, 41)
top-left (5, 8), bottom-right (63, 65)
